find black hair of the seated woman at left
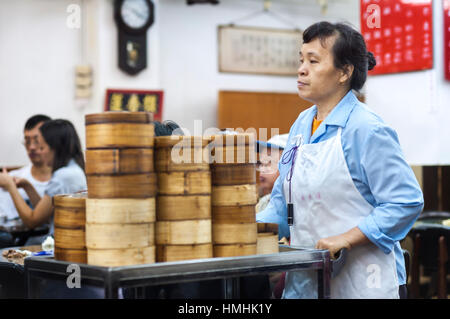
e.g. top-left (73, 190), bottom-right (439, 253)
top-left (39, 119), bottom-right (84, 172)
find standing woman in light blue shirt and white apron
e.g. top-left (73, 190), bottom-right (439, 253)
top-left (256, 22), bottom-right (423, 298)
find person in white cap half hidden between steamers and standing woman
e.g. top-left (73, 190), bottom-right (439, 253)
top-left (256, 134), bottom-right (289, 213)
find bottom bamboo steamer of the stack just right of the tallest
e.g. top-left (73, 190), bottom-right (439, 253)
top-left (156, 244), bottom-right (213, 262)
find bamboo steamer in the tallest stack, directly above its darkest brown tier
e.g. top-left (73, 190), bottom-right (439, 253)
top-left (85, 148), bottom-right (154, 175)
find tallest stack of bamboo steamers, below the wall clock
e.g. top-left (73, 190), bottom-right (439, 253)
top-left (85, 112), bottom-right (156, 267)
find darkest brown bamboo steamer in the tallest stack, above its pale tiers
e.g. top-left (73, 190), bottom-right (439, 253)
top-left (86, 173), bottom-right (156, 198)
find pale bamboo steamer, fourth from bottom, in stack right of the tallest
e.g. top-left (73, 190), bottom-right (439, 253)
top-left (157, 171), bottom-right (211, 195)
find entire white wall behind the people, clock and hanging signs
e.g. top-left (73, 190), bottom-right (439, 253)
top-left (0, 0), bottom-right (450, 165)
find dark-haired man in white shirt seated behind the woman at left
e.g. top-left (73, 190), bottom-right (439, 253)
top-left (0, 114), bottom-right (52, 247)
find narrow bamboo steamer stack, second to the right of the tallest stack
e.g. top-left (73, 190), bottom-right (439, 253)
top-left (211, 134), bottom-right (257, 257)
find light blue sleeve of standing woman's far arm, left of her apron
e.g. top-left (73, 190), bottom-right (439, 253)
top-left (256, 177), bottom-right (289, 238)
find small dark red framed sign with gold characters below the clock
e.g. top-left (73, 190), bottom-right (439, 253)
top-left (105, 89), bottom-right (164, 121)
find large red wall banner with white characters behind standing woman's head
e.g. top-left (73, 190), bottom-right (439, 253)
top-left (360, 0), bottom-right (433, 75)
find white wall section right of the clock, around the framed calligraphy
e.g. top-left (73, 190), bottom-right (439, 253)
top-left (160, 0), bottom-right (359, 133)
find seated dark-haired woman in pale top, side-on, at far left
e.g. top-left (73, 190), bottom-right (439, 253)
top-left (0, 119), bottom-right (87, 239)
